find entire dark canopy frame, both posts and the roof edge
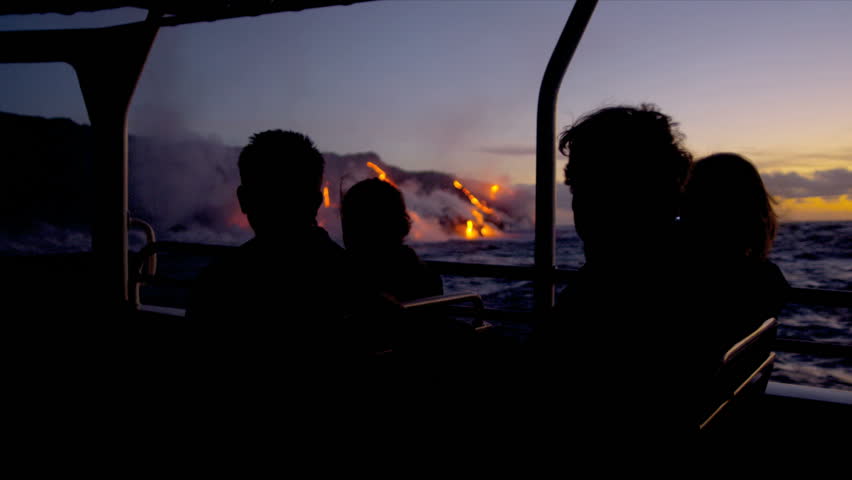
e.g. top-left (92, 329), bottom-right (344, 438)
top-left (0, 0), bottom-right (597, 311)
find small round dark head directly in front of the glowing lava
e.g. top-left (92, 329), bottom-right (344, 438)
top-left (340, 178), bottom-right (411, 250)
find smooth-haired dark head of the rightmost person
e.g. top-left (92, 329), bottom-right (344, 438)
top-left (682, 153), bottom-right (777, 259)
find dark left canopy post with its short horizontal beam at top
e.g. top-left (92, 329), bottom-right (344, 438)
top-left (0, 21), bottom-right (159, 313)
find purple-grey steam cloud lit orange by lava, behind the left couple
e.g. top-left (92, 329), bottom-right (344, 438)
top-left (130, 142), bottom-right (532, 244)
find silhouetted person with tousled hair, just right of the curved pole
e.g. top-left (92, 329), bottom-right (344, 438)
top-left (532, 105), bottom-right (691, 434)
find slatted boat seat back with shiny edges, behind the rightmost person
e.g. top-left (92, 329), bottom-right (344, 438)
top-left (699, 318), bottom-right (778, 432)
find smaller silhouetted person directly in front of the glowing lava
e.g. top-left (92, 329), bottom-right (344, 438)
top-left (340, 178), bottom-right (444, 302)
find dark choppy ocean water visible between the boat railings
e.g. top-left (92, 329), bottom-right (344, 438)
top-left (412, 222), bottom-right (852, 390)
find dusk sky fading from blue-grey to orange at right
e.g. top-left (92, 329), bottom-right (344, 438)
top-left (0, 0), bottom-right (852, 220)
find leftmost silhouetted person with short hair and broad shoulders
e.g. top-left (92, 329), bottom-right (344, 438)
top-left (187, 130), bottom-right (347, 352)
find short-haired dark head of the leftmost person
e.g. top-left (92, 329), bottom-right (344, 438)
top-left (237, 130), bottom-right (325, 235)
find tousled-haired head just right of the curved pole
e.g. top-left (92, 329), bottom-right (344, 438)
top-left (559, 105), bottom-right (692, 257)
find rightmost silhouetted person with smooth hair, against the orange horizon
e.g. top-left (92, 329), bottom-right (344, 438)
top-left (682, 153), bottom-right (789, 394)
